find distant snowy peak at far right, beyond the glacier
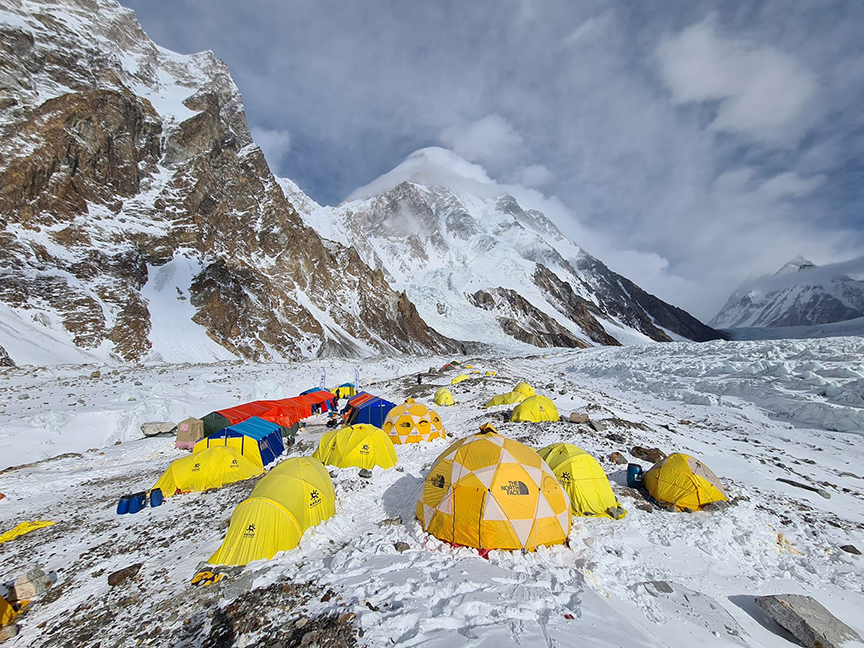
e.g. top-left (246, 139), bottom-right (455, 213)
top-left (711, 256), bottom-right (864, 329)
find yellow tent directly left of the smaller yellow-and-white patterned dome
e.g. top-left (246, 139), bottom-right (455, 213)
top-left (312, 423), bottom-right (398, 469)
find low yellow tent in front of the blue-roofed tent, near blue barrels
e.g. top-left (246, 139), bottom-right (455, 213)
top-left (153, 446), bottom-right (264, 497)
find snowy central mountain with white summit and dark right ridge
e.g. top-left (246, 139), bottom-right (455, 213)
top-left (304, 147), bottom-right (720, 350)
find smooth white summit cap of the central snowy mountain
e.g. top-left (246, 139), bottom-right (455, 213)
top-left (348, 146), bottom-right (492, 200)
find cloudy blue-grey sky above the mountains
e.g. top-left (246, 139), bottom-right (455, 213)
top-left (124, 0), bottom-right (864, 320)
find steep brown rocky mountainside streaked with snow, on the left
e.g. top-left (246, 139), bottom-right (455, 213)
top-left (0, 0), bottom-right (459, 363)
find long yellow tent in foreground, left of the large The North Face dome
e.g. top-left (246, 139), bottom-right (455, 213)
top-left (208, 457), bottom-right (336, 565)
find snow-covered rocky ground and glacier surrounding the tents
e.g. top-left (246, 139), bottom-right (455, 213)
top-left (0, 338), bottom-right (864, 648)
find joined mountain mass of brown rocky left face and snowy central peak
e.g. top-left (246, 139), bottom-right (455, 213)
top-left (0, 0), bottom-right (719, 365)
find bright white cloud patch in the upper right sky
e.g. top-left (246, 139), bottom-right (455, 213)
top-left (657, 22), bottom-right (816, 144)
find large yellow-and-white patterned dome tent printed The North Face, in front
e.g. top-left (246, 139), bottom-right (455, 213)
top-left (417, 423), bottom-right (571, 550)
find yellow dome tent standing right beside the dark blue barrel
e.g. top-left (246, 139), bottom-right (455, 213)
top-left (642, 452), bottom-right (728, 511)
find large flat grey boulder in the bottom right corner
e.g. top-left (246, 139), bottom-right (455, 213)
top-left (755, 594), bottom-right (861, 648)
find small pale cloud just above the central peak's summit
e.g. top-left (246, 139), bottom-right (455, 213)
top-left (441, 114), bottom-right (525, 164)
